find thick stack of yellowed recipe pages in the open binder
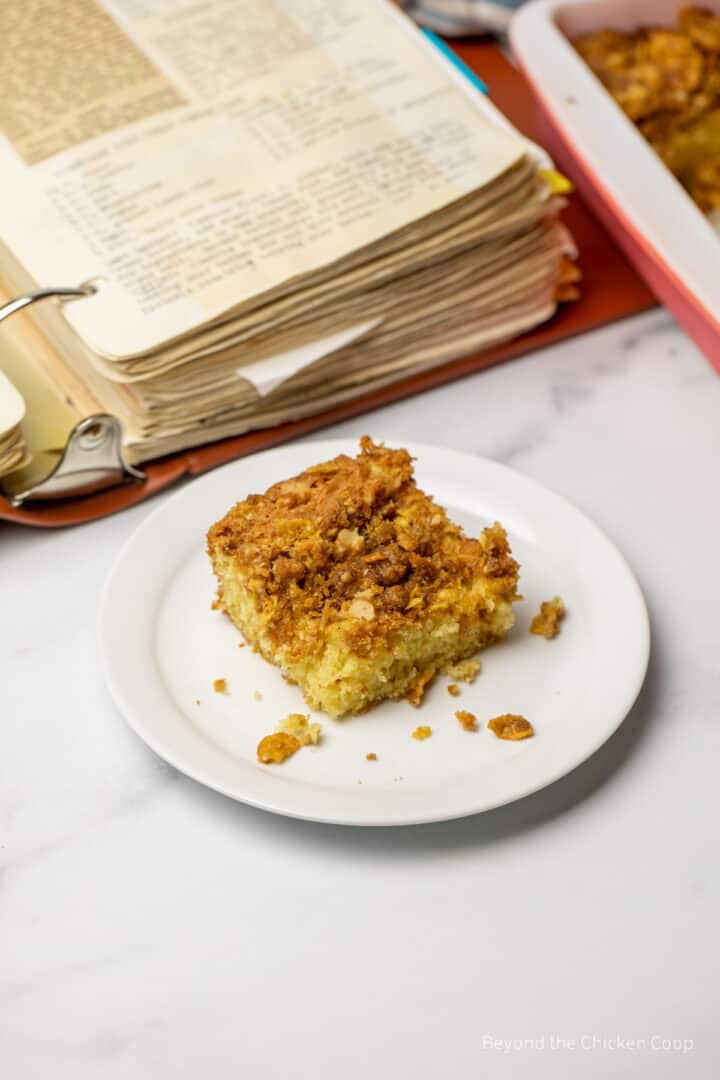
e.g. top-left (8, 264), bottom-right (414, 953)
top-left (0, 0), bottom-right (574, 486)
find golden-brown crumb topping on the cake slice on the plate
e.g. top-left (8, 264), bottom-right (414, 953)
top-left (208, 436), bottom-right (518, 656)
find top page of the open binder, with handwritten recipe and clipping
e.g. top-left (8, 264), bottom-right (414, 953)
top-left (0, 0), bottom-right (526, 357)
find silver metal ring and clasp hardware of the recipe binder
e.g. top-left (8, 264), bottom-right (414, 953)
top-left (0, 284), bottom-right (146, 507)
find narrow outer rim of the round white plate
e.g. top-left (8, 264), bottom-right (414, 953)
top-left (96, 437), bottom-right (651, 827)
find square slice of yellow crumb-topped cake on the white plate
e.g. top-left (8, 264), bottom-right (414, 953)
top-left (207, 437), bottom-right (518, 718)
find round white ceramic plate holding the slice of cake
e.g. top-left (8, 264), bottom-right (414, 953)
top-left (99, 441), bottom-right (649, 825)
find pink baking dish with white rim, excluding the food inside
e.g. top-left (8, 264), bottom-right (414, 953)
top-left (511, 0), bottom-right (720, 370)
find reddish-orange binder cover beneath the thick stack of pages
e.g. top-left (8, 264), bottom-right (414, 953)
top-left (0, 41), bottom-right (656, 527)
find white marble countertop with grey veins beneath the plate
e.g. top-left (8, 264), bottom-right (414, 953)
top-left (0, 312), bottom-right (720, 1080)
